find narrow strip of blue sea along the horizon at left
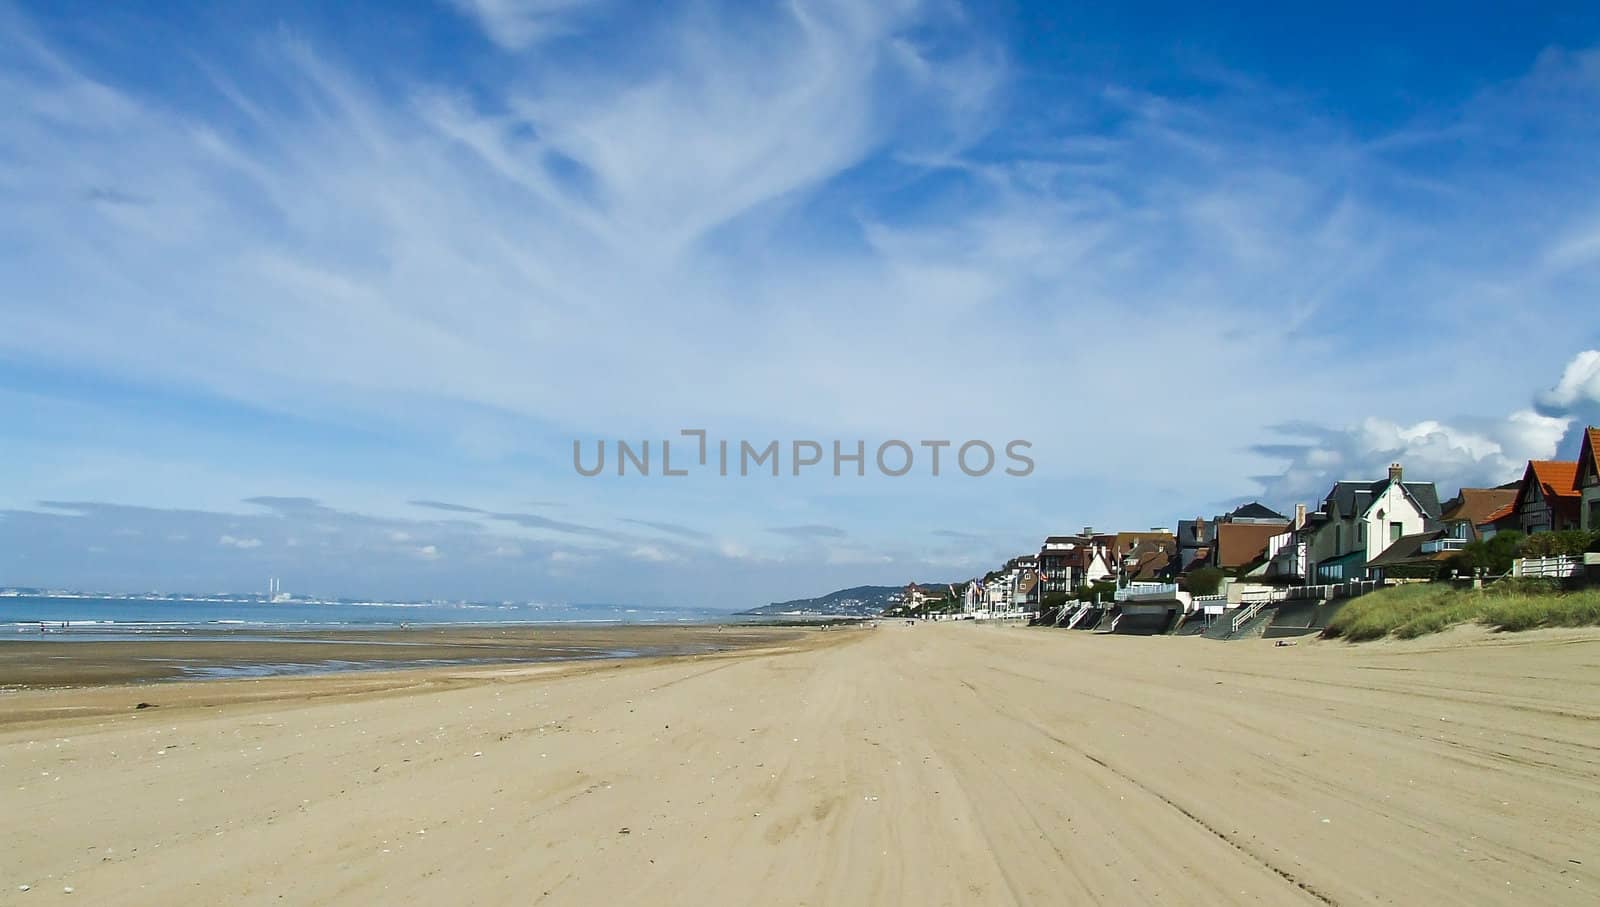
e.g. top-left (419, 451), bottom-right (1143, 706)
top-left (0, 595), bottom-right (734, 640)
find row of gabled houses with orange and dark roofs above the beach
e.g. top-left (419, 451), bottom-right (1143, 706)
top-left (963, 427), bottom-right (1600, 613)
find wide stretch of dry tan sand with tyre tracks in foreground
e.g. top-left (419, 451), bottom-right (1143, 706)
top-left (0, 624), bottom-right (1600, 905)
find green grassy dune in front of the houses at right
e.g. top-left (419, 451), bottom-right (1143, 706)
top-left (1323, 581), bottom-right (1600, 641)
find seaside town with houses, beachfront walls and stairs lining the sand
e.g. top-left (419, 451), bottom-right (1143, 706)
top-left (876, 427), bottom-right (1600, 635)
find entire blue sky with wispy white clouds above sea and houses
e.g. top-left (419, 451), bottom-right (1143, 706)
top-left (0, 0), bottom-right (1600, 606)
